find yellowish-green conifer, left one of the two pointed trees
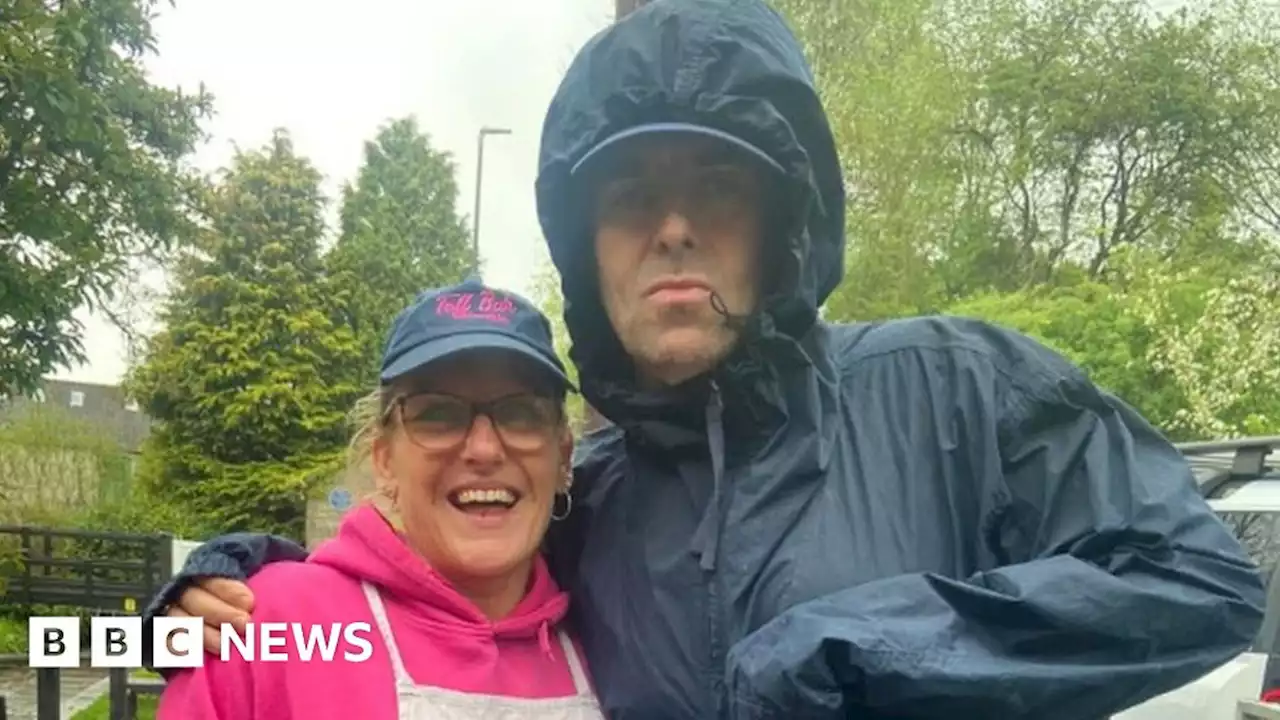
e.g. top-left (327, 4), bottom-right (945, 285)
top-left (129, 131), bottom-right (360, 537)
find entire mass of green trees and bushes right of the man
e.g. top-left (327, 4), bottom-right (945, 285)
top-left (774, 0), bottom-right (1280, 439)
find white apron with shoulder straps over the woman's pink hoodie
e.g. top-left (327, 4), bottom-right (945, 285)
top-left (361, 583), bottom-right (604, 720)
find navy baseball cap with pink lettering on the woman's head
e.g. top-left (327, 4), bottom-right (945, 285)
top-left (381, 279), bottom-right (573, 389)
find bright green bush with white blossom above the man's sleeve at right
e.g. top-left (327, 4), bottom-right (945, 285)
top-left (948, 243), bottom-right (1280, 439)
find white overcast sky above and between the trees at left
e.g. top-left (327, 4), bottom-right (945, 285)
top-left (56, 0), bottom-right (613, 384)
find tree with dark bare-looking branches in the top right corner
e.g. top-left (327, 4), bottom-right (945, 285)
top-left (947, 0), bottom-right (1280, 274)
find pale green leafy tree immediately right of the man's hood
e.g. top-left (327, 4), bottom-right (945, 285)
top-left (774, 0), bottom-right (972, 319)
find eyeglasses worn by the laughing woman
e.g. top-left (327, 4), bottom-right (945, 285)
top-left (389, 392), bottom-right (561, 452)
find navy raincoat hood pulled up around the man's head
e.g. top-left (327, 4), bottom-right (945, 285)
top-left (536, 0), bottom-right (845, 424)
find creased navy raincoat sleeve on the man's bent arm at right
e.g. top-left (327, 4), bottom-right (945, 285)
top-left (727, 338), bottom-right (1265, 720)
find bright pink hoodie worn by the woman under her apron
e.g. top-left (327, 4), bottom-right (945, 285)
top-left (157, 506), bottom-right (593, 720)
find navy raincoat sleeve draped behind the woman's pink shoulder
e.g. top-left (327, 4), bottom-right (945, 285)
top-left (142, 533), bottom-right (307, 676)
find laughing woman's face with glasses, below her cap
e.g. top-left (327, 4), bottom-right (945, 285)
top-left (374, 351), bottom-right (572, 579)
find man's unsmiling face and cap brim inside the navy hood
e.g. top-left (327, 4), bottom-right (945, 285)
top-left (594, 136), bottom-right (764, 384)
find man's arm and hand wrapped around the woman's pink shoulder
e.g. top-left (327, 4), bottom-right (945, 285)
top-left (142, 533), bottom-right (307, 674)
